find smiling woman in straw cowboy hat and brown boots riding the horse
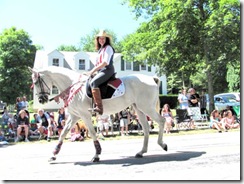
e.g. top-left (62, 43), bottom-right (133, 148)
top-left (87, 30), bottom-right (115, 115)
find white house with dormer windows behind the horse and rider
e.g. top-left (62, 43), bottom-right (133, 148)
top-left (33, 50), bottom-right (167, 110)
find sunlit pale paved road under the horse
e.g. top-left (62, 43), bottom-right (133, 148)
top-left (0, 131), bottom-right (240, 180)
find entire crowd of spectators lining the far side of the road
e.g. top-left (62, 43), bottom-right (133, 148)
top-left (0, 88), bottom-right (240, 142)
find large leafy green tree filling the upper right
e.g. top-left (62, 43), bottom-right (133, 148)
top-left (122, 0), bottom-right (240, 110)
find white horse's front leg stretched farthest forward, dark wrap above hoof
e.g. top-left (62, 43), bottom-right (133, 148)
top-left (48, 117), bottom-right (76, 162)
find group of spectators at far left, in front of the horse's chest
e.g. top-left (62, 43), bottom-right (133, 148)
top-left (0, 96), bottom-right (71, 142)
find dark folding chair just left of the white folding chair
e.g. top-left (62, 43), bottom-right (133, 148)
top-left (175, 109), bottom-right (193, 130)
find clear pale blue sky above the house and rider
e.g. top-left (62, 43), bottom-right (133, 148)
top-left (0, 0), bottom-right (142, 51)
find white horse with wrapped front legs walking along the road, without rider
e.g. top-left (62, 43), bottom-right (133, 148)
top-left (30, 66), bottom-right (168, 162)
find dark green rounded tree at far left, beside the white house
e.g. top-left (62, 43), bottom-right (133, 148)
top-left (0, 27), bottom-right (36, 104)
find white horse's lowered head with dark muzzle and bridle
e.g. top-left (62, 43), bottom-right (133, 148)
top-left (29, 68), bottom-right (50, 104)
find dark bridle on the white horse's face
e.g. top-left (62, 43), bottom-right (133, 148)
top-left (33, 73), bottom-right (50, 104)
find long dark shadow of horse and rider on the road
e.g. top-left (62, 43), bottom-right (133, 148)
top-left (50, 151), bottom-right (206, 167)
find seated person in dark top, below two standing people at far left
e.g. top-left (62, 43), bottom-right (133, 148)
top-left (15, 110), bottom-right (29, 142)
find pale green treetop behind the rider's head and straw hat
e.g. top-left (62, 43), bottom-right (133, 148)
top-left (79, 29), bottom-right (122, 53)
